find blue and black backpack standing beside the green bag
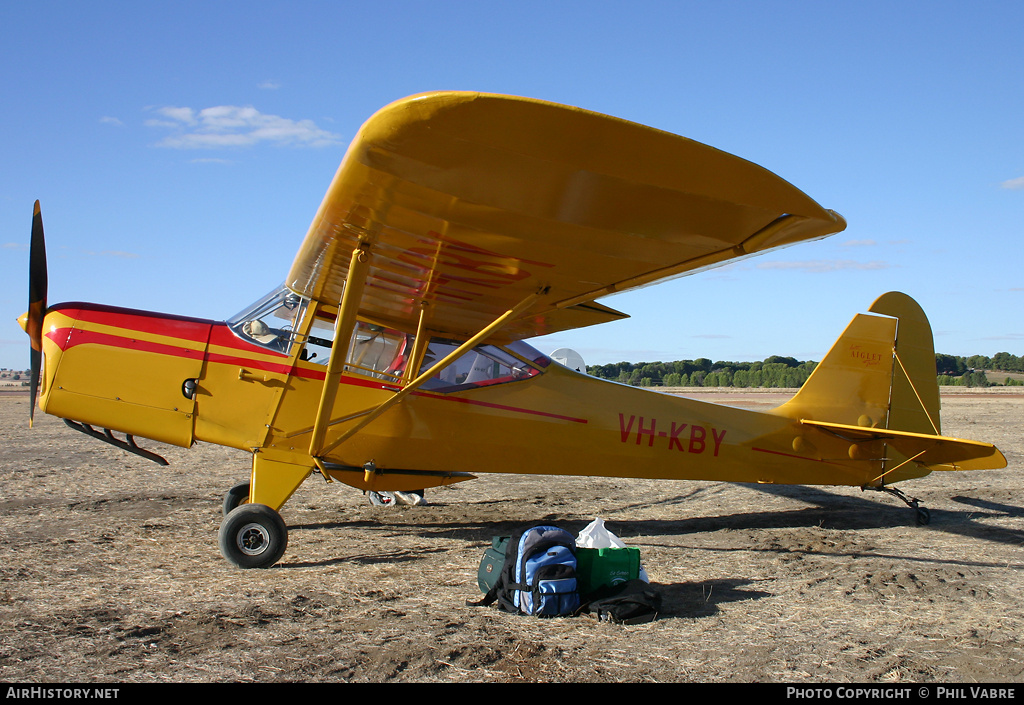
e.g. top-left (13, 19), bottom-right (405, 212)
top-left (467, 527), bottom-right (580, 617)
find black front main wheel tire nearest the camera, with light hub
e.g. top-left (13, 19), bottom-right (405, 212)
top-left (217, 504), bottom-right (288, 568)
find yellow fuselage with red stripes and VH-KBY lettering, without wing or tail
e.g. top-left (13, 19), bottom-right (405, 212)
top-left (34, 303), bottom-right (920, 495)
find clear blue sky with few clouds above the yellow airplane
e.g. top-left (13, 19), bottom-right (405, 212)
top-left (0, 0), bottom-right (1024, 375)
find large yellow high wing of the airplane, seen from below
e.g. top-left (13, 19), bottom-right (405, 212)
top-left (286, 92), bottom-right (846, 340)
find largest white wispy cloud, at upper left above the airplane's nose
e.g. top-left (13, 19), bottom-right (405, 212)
top-left (145, 106), bottom-right (341, 150)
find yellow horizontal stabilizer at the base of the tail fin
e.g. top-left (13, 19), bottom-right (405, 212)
top-left (801, 419), bottom-right (1007, 470)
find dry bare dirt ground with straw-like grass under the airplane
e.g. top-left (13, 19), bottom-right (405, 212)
top-left (0, 387), bottom-right (1024, 683)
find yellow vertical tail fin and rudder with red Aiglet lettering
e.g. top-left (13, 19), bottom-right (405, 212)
top-left (777, 292), bottom-right (941, 436)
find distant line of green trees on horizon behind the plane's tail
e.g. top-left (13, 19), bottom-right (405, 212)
top-left (587, 353), bottom-right (1024, 388)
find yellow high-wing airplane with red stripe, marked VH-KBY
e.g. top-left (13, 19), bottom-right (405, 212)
top-left (20, 92), bottom-right (1006, 568)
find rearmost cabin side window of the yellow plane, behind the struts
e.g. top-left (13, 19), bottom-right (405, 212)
top-left (420, 338), bottom-right (540, 391)
